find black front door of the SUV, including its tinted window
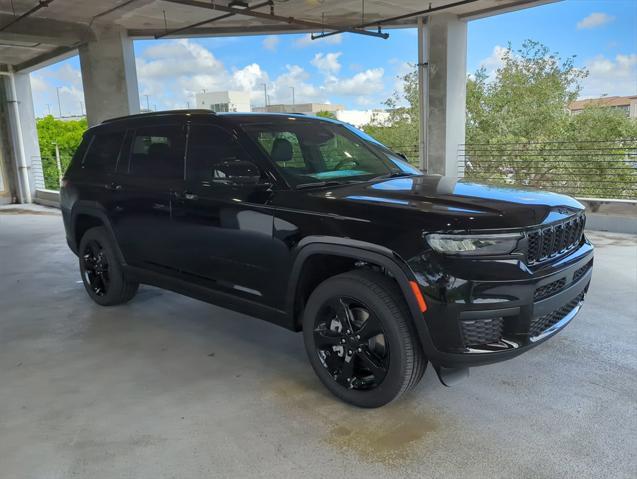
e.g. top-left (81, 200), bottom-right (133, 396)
top-left (172, 123), bottom-right (276, 304)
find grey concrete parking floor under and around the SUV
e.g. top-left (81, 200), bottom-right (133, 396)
top-left (0, 209), bottom-right (637, 479)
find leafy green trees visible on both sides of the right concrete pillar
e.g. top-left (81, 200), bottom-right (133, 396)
top-left (363, 40), bottom-right (637, 198)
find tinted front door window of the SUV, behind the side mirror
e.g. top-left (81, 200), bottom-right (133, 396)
top-left (188, 125), bottom-right (251, 181)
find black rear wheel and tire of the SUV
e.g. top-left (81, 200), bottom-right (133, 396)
top-left (78, 226), bottom-right (139, 306)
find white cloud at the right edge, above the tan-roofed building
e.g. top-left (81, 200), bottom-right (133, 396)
top-left (580, 53), bottom-right (637, 98)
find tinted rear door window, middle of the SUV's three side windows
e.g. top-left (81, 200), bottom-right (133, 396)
top-left (129, 125), bottom-right (186, 179)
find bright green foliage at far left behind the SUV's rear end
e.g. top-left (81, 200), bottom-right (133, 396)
top-left (36, 115), bottom-right (88, 190)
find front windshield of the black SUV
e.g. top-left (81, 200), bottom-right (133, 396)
top-left (243, 118), bottom-right (420, 186)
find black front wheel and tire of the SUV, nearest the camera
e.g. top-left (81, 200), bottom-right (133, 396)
top-left (303, 270), bottom-right (427, 408)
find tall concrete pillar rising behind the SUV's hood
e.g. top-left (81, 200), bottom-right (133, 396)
top-left (426, 14), bottom-right (467, 176)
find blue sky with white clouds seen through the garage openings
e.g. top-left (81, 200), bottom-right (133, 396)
top-left (31, 0), bottom-right (637, 116)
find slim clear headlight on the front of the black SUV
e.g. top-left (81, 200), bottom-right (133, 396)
top-left (426, 233), bottom-right (522, 256)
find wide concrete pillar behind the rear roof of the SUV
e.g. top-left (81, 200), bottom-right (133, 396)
top-left (79, 27), bottom-right (139, 126)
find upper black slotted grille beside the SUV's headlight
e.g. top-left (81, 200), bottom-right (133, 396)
top-left (527, 214), bottom-right (586, 264)
